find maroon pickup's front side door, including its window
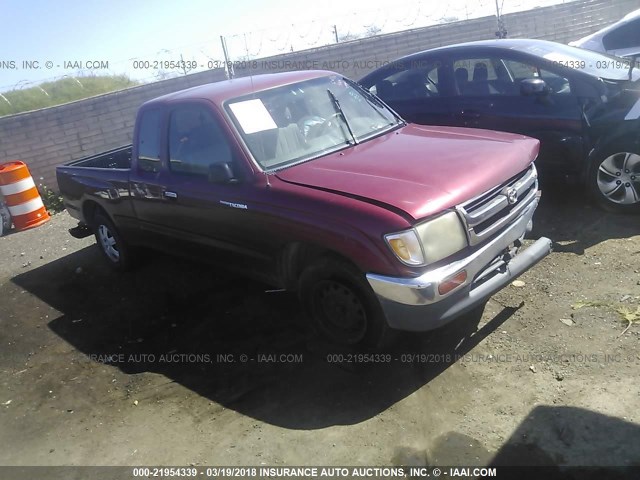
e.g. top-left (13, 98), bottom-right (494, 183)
top-left (138, 102), bottom-right (268, 258)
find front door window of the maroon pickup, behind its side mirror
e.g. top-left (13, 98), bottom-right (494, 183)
top-left (169, 105), bottom-right (232, 177)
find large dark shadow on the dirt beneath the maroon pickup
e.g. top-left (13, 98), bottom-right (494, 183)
top-left (12, 247), bottom-right (516, 429)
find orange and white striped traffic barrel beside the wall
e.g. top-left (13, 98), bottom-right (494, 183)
top-left (0, 161), bottom-right (51, 231)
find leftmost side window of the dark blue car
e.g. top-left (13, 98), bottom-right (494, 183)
top-left (369, 60), bottom-right (441, 101)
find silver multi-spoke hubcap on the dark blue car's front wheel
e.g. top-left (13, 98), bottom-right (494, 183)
top-left (598, 152), bottom-right (640, 205)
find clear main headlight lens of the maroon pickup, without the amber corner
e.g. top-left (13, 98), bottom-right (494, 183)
top-left (416, 212), bottom-right (467, 263)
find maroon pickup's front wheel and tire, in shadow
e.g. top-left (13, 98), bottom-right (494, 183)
top-left (299, 258), bottom-right (389, 348)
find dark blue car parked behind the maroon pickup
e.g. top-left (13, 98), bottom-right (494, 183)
top-left (360, 39), bottom-right (640, 212)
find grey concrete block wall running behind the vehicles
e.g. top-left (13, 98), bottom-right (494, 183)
top-left (0, 0), bottom-right (640, 189)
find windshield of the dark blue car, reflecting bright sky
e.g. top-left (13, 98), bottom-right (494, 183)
top-left (518, 42), bottom-right (640, 80)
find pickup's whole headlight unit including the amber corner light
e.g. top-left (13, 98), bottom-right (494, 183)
top-left (384, 212), bottom-right (467, 266)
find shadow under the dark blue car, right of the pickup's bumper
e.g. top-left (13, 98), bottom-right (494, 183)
top-left (531, 182), bottom-right (640, 255)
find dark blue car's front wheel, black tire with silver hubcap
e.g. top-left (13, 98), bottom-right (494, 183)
top-left (587, 142), bottom-right (640, 213)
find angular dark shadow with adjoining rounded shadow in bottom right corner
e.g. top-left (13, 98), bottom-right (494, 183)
top-left (391, 405), bottom-right (640, 480)
